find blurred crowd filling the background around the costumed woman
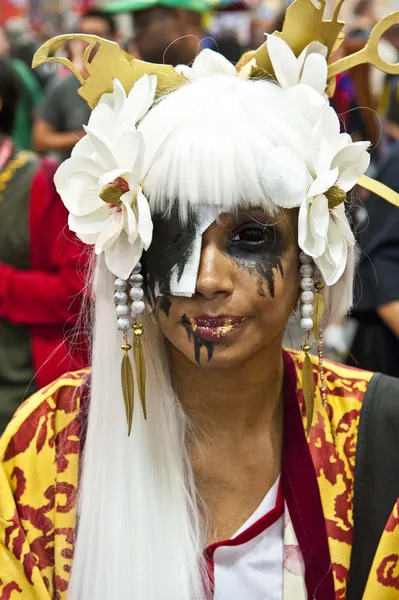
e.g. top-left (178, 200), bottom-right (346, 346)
top-left (0, 0), bottom-right (399, 432)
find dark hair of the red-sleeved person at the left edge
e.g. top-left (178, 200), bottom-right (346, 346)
top-left (0, 59), bottom-right (20, 135)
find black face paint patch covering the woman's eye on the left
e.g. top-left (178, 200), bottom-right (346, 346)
top-left (141, 210), bottom-right (198, 306)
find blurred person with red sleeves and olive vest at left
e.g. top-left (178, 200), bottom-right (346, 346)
top-left (0, 59), bottom-right (87, 433)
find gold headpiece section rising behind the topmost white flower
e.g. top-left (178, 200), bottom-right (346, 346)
top-left (237, 0), bottom-right (345, 78)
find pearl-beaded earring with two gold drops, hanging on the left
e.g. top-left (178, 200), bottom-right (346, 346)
top-left (114, 263), bottom-right (147, 436)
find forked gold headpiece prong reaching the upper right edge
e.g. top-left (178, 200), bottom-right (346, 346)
top-left (328, 11), bottom-right (399, 78)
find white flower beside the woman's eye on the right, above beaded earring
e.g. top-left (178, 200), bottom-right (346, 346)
top-left (272, 107), bottom-right (370, 285)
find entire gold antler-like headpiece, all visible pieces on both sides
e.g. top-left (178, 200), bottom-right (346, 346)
top-left (33, 0), bottom-right (399, 206)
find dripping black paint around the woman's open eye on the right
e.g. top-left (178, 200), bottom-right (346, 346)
top-left (228, 221), bottom-right (286, 298)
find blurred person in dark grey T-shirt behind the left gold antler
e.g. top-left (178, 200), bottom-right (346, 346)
top-left (33, 10), bottom-right (117, 161)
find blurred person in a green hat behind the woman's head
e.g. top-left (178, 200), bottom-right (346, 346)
top-left (109, 0), bottom-right (208, 66)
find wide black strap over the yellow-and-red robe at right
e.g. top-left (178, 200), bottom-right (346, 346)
top-left (346, 373), bottom-right (399, 600)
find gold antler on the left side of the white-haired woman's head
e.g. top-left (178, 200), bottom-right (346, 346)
top-left (32, 34), bottom-right (187, 108)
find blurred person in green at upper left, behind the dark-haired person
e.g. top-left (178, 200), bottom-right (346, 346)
top-left (0, 25), bottom-right (42, 150)
